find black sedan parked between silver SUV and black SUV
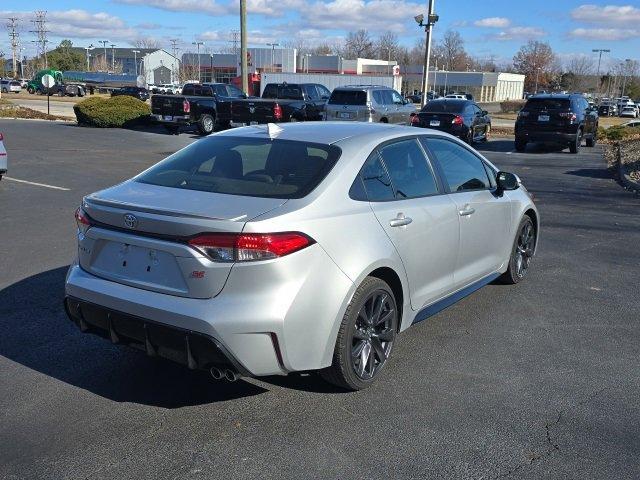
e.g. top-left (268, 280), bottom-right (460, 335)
top-left (411, 98), bottom-right (491, 143)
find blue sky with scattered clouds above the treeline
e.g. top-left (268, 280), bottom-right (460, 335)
top-left (6, 0), bottom-right (640, 68)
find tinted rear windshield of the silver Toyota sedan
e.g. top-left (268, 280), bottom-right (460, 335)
top-left (135, 136), bottom-right (341, 198)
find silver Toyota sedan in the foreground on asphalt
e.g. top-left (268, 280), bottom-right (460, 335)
top-left (65, 122), bottom-right (539, 390)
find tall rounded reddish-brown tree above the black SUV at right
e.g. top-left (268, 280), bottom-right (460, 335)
top-left (513, 40), bottom-right (558, 92)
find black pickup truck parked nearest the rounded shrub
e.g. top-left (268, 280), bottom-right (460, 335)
top-left (151, 83), bottom-right (247, 135)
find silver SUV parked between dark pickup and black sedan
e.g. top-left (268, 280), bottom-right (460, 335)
top-left (325, 85), bottom-right (417, 125)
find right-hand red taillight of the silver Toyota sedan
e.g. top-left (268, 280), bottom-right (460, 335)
top-left (189, 232), bottom-right (314, 262)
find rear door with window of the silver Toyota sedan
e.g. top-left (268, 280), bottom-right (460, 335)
top-left (361, 138), bottom-right (459, 309)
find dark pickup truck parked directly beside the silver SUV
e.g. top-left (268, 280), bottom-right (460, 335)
top-left (231, 83), bottom-right (331, 125)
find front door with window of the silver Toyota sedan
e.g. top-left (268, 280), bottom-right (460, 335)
top-left (424, 137), bottom-right (513, 288)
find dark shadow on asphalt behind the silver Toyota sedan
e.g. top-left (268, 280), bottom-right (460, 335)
top-left (0, 267), bottom-right (267, 408)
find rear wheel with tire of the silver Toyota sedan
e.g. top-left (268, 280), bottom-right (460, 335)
top-left (320, 277), bottom-right (399, 390)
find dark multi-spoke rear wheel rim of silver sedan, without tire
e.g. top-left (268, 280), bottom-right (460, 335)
top-left (351, 290), bottom-right (397, 380)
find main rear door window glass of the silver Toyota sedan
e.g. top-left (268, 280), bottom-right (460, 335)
top-left (380, 139), bottom-right (438, 200)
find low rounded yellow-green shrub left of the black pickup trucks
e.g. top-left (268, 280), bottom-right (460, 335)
top-left (73, 95), bottom-right (151, 128)
